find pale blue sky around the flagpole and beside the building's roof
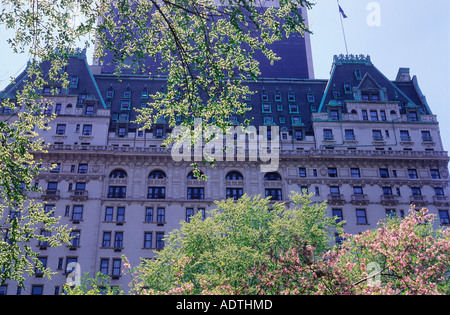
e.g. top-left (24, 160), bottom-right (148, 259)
top-left (0, 0), bottom-right (450, 150)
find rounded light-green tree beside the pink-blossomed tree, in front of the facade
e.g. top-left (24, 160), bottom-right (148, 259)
top-left (125, 193), bottom-right (341, 294)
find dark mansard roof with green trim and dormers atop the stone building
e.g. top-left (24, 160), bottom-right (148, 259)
top-left (0, 52), bottom-right (431, 133)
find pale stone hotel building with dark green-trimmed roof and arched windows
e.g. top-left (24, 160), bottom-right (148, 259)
top-left (1, 48), bottom-right (450, 294)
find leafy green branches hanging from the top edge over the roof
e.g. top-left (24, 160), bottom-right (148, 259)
top-left (0, 0), bottom-right (313, 175)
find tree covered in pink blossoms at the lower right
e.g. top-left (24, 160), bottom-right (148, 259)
top-left (253, 206), bottom-right (450, 295)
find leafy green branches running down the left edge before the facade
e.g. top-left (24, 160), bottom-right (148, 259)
top-left (0, 61), bottom-right (70, 284)
